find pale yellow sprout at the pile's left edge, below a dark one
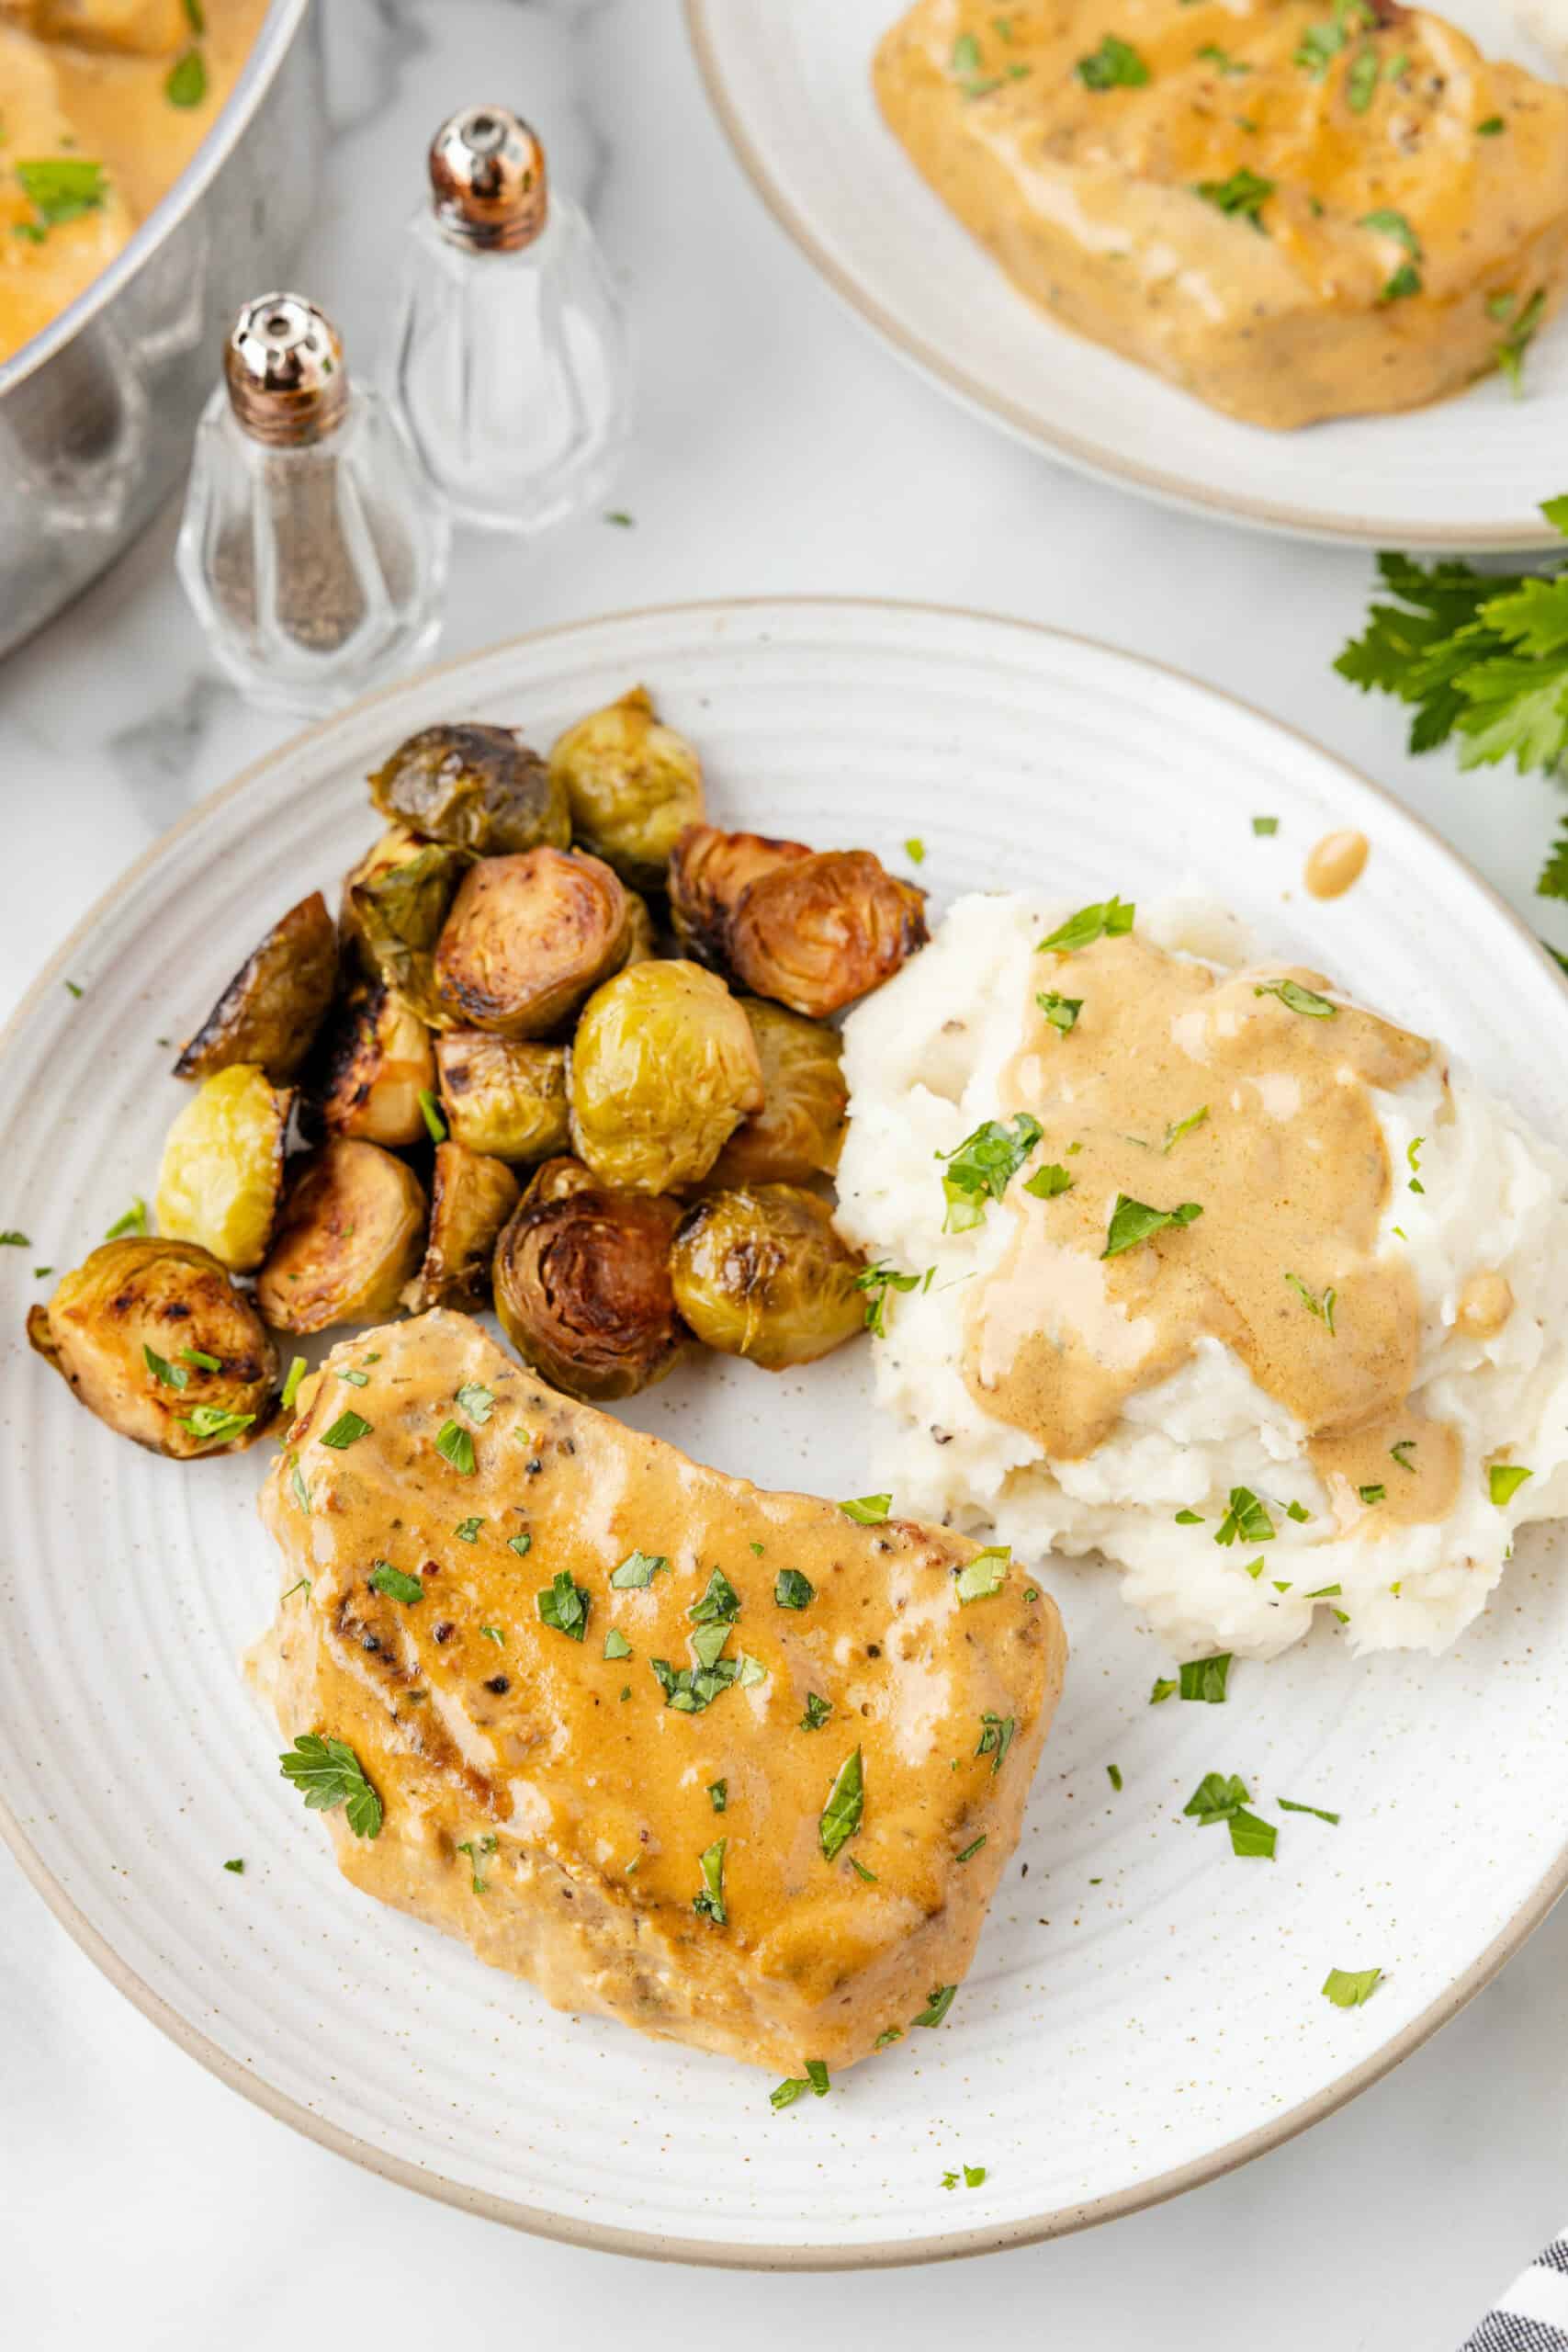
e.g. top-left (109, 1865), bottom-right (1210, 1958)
top-left (157, 1061), bottom-right (294, 1275)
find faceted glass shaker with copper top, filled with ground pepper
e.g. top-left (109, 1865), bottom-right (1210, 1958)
top-left (176, 294), bottom-right (449, 715)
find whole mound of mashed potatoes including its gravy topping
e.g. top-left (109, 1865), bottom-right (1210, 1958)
top-left (837, 896), bottom-right (1568, 1656)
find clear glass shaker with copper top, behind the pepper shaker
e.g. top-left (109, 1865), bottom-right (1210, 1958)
top-left (388, 106), bottom-right (630, 534)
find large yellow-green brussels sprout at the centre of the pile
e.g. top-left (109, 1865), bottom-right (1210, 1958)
top-left (571, 959), bottom-right (761, 1193)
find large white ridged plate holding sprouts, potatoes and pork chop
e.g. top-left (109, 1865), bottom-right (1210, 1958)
top-left (0, 602), bottom-right (1568, 2263)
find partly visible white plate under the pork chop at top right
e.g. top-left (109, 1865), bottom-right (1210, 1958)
top-left (686, 0), bottom-right (1568, 548)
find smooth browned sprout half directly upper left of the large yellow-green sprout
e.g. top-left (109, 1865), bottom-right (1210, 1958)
top-left (434, 849), bottom-right (630, 1037)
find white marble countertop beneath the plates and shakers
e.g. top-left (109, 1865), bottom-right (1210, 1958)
top-left (0, 0), bottom-right (1568, 2352)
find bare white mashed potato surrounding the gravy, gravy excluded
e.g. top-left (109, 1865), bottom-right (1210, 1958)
top-left (837, 894), bottom-right (1568, 1658)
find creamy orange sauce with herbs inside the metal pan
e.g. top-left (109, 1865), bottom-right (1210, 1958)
top-left (0, 0), bottom-right (268, 360)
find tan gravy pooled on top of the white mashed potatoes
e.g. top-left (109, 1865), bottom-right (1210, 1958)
top-left (966, 933), bottom-right (1458, 1526)
